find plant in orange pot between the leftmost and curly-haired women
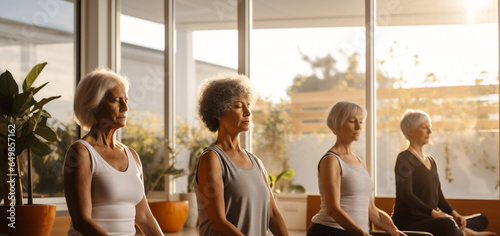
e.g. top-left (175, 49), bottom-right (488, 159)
top-left (122, 115), bottom-right (189, 232)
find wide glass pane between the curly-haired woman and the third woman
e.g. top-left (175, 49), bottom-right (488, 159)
top-left (250, 0), bottom-right (365, 193)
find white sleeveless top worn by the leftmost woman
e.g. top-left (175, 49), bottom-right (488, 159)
top-left (68, 139), bottom-right (144, 236)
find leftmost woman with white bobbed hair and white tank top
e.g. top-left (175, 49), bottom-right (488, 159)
top-left (63, 68), bottom-right (163, 236)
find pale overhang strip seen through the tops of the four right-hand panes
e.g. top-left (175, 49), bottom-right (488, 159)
top-left (121, 0), bottom-right (498, 29)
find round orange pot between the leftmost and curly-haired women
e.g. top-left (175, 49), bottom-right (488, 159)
top-left (149, 201), bottom-right (189, 232)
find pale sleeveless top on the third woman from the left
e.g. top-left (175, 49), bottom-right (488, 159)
top-left (312, 151), bottom-right (373, 232)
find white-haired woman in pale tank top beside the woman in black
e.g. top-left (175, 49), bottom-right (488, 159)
top-left (307, 101), bottom-right (428, 236)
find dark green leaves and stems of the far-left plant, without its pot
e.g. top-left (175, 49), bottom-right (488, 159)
top-left (0, 62), bottom-right (61, 205)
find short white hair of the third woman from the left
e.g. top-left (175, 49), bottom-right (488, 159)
top-left (326, 101), bottom-right (367, 134)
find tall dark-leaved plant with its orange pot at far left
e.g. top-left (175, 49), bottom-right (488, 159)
top-left (0, 63), bottom-right (61, 235)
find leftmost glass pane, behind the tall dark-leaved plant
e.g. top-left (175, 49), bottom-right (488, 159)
top-left (0, 0), bottom-right (77, 197)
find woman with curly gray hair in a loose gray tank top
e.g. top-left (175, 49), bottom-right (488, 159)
top-left (195, 74), bottom-right (288, 236)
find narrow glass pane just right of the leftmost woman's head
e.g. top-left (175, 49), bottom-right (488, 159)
top-left (120, 0), bottom-right (164, 193)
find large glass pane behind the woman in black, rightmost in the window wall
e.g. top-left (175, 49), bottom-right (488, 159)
top-left (375, 0), bottom-right (499, 198)
